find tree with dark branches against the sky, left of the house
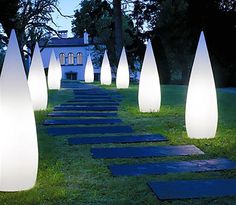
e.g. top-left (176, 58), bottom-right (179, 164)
top-left (0, 0), bottom-right (58, 62)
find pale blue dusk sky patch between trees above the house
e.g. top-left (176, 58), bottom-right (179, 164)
top-left (53, 0), bottom-right (80, 37)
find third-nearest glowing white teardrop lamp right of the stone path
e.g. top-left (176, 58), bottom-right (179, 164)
top-left (116, 48), bottom-right (129, 89)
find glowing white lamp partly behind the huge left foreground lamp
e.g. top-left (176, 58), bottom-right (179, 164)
top-left (28, 43), bottom-right (48, 110)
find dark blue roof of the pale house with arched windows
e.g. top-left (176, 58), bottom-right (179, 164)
top-left (39, 37), bottom-right (100, 47)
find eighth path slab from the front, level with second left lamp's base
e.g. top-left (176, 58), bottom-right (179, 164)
top-left (54, 106), bottom-right (118, 111)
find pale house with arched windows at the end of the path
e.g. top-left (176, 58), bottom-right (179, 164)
top-left (39, 30), bottom-right (105, 80)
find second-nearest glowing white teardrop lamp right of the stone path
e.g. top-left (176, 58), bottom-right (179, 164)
top-left (138, 40), bottom-right (161, 112)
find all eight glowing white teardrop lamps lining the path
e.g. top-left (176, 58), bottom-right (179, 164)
top-left (0, 30), bottom-right (218, 192)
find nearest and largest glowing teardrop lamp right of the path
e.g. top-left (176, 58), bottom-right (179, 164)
top-left (185, 32), bottom-right (218, 138)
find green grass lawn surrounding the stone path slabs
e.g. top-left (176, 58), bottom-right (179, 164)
top-left (0, 85), bottom-right (236, 205)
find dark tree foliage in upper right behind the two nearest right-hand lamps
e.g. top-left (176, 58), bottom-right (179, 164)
top-left (130, 0), bottom-right (236, 86)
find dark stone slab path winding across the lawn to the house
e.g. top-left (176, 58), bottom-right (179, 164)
top-left (44, 82), bottom-right (236, 200)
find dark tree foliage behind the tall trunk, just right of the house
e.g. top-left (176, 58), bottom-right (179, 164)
top-left (72, 0), bottom-right (143, 67)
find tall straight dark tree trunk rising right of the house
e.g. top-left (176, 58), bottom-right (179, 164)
top-left (113, 0), bottom-right (123, 64)
